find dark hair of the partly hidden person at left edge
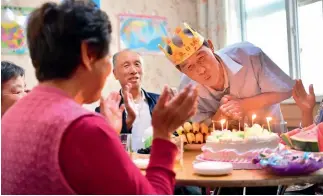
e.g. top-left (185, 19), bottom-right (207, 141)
top-left (1, 61), bottom-right (25, 84)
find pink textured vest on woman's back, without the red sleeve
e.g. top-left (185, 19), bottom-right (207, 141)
top-left (1, 86), bottom-right (95, 195)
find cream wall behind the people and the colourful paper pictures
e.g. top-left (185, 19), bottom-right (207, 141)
top-left (1, 0), bottom-right (197, 109)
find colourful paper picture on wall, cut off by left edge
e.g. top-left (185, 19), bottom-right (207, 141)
top-left (1, 6), bottom-right (33, 54)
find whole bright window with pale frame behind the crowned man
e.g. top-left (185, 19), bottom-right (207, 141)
top-left (240, 0), bottom-right (323, 96)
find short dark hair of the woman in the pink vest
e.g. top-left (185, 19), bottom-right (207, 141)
top-left (27, 0), bottom-right (112, 81)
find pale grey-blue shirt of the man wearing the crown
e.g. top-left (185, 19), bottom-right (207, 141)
top-left (179, 42), bottom-right (295, 124)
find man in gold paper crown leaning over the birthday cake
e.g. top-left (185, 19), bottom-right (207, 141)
top-left (159, 23), bottom-right (294, 128)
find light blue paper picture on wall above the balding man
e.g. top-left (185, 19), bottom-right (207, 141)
top-left (118, 14), bottom-right (167, 54)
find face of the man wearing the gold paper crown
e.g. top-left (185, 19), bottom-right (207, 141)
top-left (179, 46), bottom-right (221, 87)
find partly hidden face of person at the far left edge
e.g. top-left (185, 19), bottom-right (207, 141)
top-left (1, 76), bottom-right (27, 114)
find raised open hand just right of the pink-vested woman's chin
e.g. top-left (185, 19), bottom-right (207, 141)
top-left (100, 92), bottom-right (125, 133)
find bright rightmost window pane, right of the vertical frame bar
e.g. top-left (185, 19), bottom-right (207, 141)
top-left (298, 1), bottom-right (323, 95)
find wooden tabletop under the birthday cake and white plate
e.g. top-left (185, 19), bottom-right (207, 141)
top-left (143, 151), bottom-right (323, 188)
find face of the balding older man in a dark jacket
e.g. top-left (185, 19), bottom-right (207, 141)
top-left (113, 51), bottom-right (143, 87)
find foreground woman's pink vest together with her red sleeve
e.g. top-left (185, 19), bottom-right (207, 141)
top-left (1, 86), bottom-right (177, 195)
